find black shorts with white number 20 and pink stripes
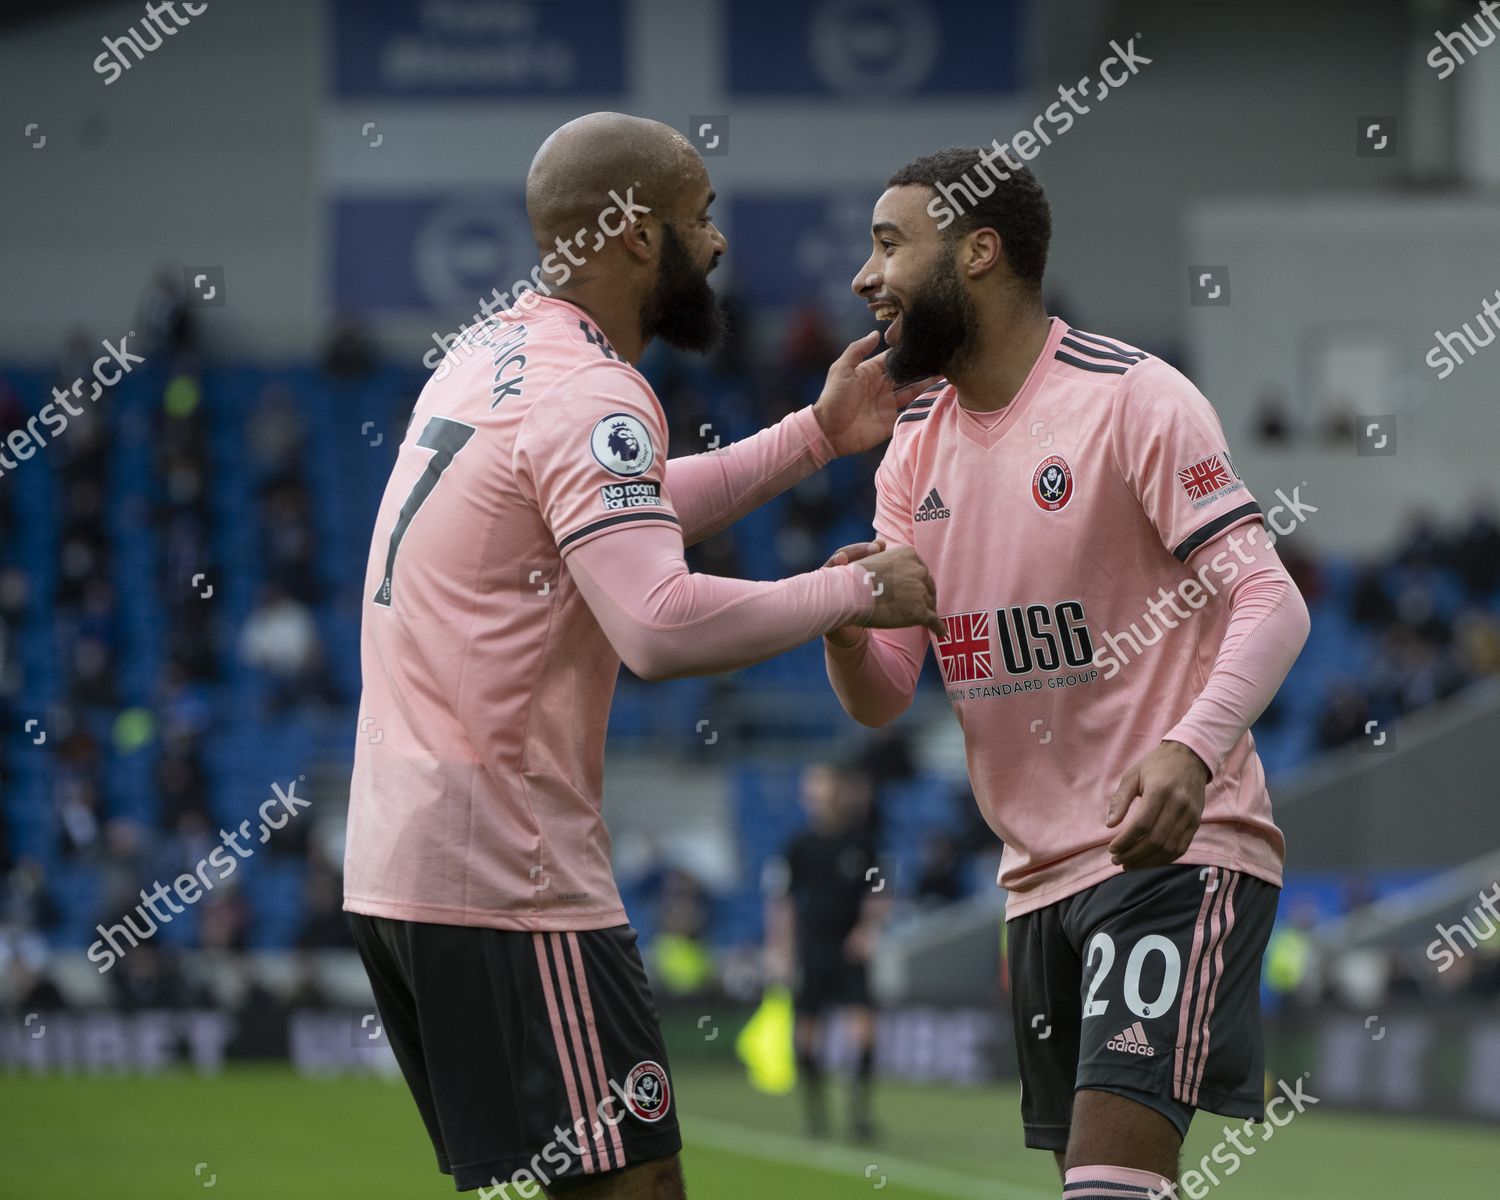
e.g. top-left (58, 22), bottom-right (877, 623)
top-left (1007, 864), bottom-right (1281, 1151)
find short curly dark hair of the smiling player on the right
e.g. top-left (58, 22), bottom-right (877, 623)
top-left (885, 146), bottom-right (1052, 291)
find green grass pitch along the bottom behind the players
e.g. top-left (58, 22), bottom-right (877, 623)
top-left (0, 1064), bottom-right (1500, 1200)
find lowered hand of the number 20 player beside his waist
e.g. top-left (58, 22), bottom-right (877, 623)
top-left (1104, 741), bottom-right (1209, 870)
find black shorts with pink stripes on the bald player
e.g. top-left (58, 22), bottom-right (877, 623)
top-left (350, 914), bottom-right (683, 1197)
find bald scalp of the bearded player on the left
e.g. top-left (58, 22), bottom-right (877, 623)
top-left (527, 113), bottom-right (708, 249)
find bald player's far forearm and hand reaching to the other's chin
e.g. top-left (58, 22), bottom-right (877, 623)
top-left (666, 332), bottom-right (926, 546)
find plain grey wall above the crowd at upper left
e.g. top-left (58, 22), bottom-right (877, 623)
top-left (0, 0), bottom-right (323, 362)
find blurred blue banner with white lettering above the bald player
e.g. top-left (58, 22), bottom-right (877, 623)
top-left (329, 0), bottom-right (626, 99)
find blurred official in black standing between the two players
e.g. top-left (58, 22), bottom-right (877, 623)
top-left (765, 762), bottom-right (890, 1142)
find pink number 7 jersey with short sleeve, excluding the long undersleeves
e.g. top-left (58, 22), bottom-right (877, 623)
top-left (345, 297), bottom-right (678, 930)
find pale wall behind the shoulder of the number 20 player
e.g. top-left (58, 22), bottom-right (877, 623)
top-left (1187, 195), bottom-right (1500, 549)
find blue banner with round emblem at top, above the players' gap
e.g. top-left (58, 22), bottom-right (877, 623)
top-left (726, 0), bottom-right (1023, 104)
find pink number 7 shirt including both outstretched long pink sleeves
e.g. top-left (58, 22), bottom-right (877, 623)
top-left (345, 299), bottom-right (873, 930)
